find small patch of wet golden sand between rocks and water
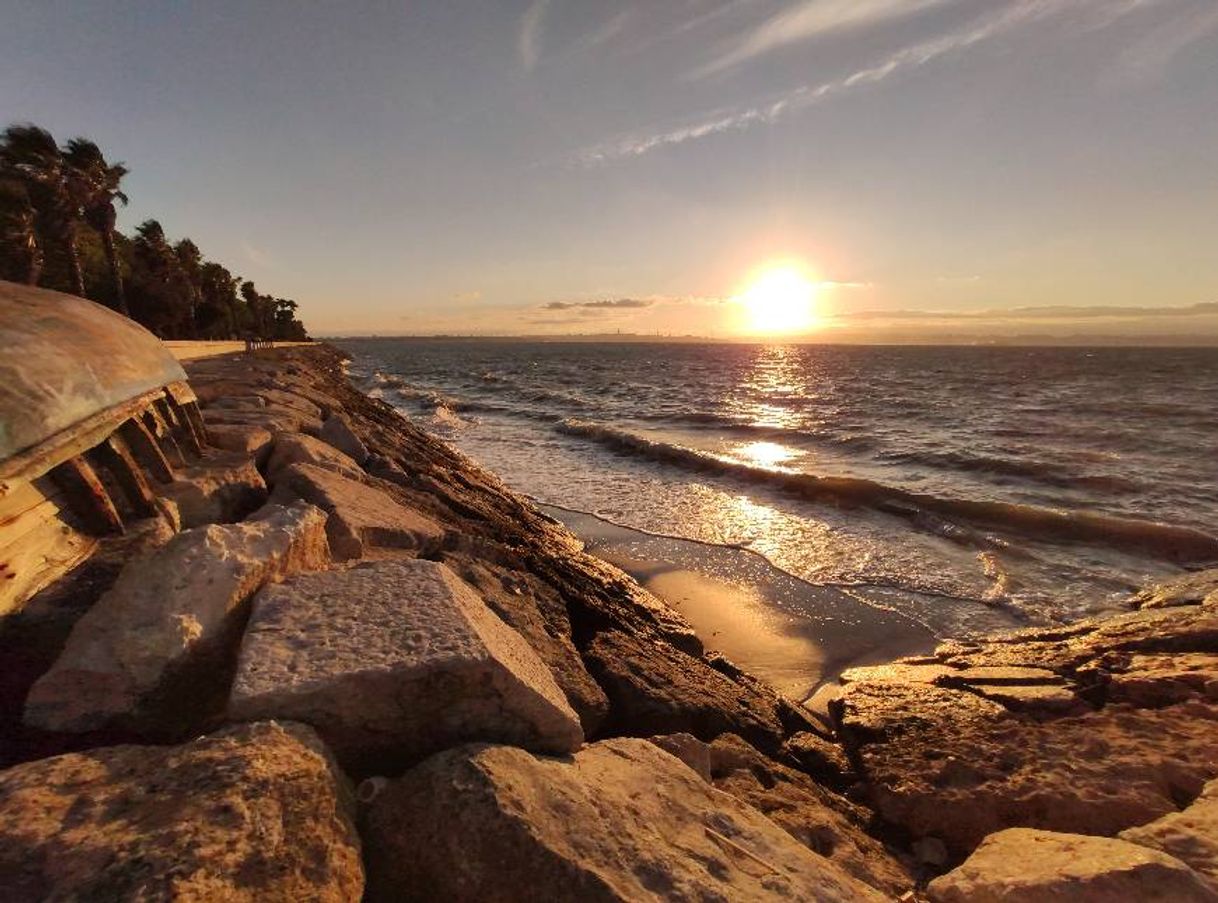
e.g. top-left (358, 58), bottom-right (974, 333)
top-left (543, 506), bottom-right (935, 702)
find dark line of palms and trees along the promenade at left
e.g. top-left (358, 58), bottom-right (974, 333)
top-left (0, 123), bottom-right (308, 341)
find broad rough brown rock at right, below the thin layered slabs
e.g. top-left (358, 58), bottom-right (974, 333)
top-left (833, 684), bottom-right (1218, 855)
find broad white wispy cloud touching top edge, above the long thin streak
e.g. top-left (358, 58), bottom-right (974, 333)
top-left (691, 0), bottom-right (956, 78)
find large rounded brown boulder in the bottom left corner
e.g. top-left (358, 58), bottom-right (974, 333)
top-left (0, 723), bottom-right (363, 903)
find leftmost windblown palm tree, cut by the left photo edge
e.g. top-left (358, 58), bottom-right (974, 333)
top-left (0, 123), bottom-right (84, 297)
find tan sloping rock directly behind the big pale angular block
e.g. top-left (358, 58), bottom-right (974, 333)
top-left (272, 464), bottom-right (445, 561)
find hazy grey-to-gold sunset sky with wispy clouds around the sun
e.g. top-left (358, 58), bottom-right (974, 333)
top-left (0, 0), bottom-right (1218, 341)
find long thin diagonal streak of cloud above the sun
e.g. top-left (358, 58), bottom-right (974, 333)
top-left (575, 0), bottom-right (1161, 166)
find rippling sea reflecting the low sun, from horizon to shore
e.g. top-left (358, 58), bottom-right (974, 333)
top-left (339, 339), bottom-right (1218, 636)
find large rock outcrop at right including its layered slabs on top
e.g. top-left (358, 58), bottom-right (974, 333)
top-left (829, 604), bottom-right (1218, 855)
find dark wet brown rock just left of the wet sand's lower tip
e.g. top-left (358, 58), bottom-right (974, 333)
top-left (583, 630), bottom-right (783, 749)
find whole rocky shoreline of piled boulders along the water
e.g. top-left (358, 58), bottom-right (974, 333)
top-left (0, 346), bottom-right (1218, 901)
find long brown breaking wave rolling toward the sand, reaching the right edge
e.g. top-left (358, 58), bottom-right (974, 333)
top-left (557, 419), bottom-right (1218, 564)
